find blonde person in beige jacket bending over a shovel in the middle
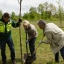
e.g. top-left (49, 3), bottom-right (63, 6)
top-left (23, 20), bottom-right (38, 60)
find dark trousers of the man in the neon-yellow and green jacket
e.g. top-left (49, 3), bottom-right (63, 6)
top-left (0, 37), bottom-right (15, 62)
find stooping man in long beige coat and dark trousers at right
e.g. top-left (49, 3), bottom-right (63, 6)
top-left (38, 20), bottom-right (64, 62)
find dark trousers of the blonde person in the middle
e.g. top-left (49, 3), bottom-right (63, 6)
top-left (29, 38), bottom-right (36, 58)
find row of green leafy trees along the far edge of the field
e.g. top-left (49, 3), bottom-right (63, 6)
top-left (0, 0), bottom-right (64, 22)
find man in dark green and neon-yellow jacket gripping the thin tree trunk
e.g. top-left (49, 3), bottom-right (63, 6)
top-left (0, 12), bottom-right (22, 64)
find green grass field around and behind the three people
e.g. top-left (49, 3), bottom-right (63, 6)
top-left (0, 22), bottom-right (64, 64)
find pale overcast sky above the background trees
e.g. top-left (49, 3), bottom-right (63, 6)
top-left (0, 0), bottom-right (64, 14)
